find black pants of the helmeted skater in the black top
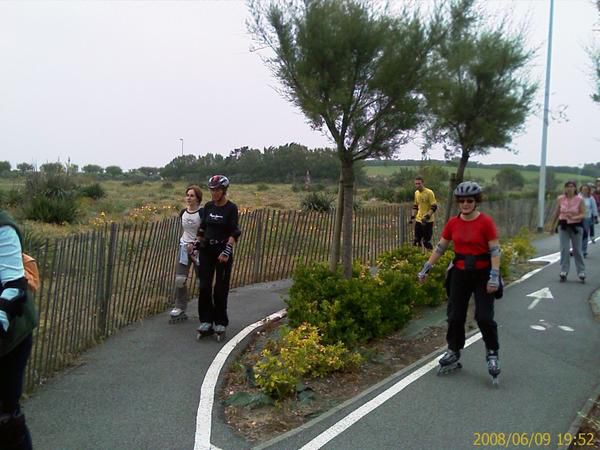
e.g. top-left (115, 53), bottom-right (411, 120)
top-left (198, 244), bottom-right (233, 326)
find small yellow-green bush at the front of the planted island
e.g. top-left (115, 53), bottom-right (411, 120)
top-left (254, 323), bottom-right (361, 398)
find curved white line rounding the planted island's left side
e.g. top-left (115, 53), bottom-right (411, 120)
top-left (194, 309), bottom-right (287, 450)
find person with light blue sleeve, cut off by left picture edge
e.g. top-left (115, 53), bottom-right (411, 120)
top-left (0, 210), bottom-right (37, 450)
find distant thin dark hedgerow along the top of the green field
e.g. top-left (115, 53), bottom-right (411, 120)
top-left (365, 159), bottom-right (600, 177)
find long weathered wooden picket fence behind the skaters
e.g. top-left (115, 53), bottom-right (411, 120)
top-left (19, 202), bottom-right (552, 392)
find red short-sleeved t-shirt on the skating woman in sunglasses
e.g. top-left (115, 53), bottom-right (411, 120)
top-left (442, 213), bottom-right (498, 269)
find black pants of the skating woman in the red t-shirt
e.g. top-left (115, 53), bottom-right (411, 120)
top-left (446, 268), bottom-right (499, 351)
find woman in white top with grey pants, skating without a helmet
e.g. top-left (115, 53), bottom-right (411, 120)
top-left (169, 185), bottom-right (202, 323)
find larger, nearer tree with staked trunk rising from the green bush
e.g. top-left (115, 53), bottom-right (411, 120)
top-left (248, 0), bottom-right (440, 277)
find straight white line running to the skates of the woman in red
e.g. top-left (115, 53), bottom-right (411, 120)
top-left (300, 333), bottom-right (481, 450)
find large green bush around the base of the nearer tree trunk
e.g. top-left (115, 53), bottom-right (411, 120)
top-left (287, 263), bottom-right (416, 347)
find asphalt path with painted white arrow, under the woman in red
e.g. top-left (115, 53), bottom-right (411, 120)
top-left (262, 237), bottom-right (600, 449)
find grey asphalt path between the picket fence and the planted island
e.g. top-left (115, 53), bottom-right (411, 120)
top-left (24, 281), bottom-right (289, 450)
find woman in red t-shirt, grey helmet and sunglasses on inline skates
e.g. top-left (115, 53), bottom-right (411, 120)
top-left (418, 181), bottom-right (501, 383)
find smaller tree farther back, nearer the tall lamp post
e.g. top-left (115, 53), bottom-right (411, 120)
top-left (424, 0), bottom-right (537, 220)
